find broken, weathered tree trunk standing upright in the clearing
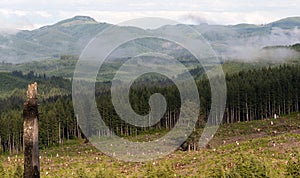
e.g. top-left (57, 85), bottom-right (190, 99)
top-left (23, 82), bottom-right (40, 178)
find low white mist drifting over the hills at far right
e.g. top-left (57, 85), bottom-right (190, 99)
top-left (219, 28), bottom-right (300, 62)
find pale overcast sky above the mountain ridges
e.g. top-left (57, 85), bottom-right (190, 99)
top-left (0, 0), bottom-right (300, 30)
